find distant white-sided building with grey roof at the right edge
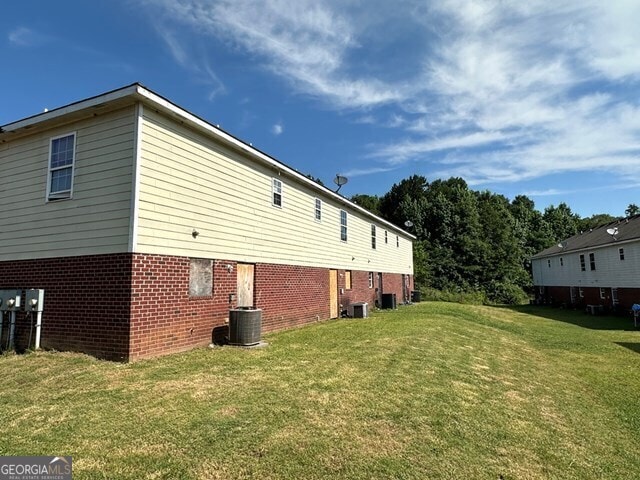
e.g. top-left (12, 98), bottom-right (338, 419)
top-left (532, 215), bottom-right (640, 311)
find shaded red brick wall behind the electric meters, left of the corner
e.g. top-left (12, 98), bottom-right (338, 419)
top-left (0, 254), bottom-right (131, 360)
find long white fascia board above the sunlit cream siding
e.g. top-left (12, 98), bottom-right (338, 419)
top-left (136, 85), bottom-right (416, 240)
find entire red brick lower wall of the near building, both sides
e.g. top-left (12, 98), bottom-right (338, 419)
top-left (0, 254), bottom-right (412, 361)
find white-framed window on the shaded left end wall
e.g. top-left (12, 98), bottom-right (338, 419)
top-left (47, 133), bottom-right (76, 200)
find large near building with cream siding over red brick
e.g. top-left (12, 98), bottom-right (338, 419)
top-left (0, 84), bottom-right (415, 360)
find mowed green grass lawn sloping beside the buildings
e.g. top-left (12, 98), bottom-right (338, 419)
top-left (0, 302), bottom-right (640, 480)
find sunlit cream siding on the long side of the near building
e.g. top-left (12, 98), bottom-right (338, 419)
top-left (136, 108), bottom-right (413, 273)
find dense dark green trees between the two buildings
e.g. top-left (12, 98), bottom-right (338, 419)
top-left (351, 175), bottom-right (640, 303)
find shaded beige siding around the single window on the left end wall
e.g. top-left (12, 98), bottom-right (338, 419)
top-left (0, 106), bottom-right (135, 260)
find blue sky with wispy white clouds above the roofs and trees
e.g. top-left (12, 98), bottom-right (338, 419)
top-left (0, 0), bottom-right (640, 216)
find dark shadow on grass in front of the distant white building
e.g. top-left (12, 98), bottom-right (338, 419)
top-left (504, 305), bottom-right (638, 332)
